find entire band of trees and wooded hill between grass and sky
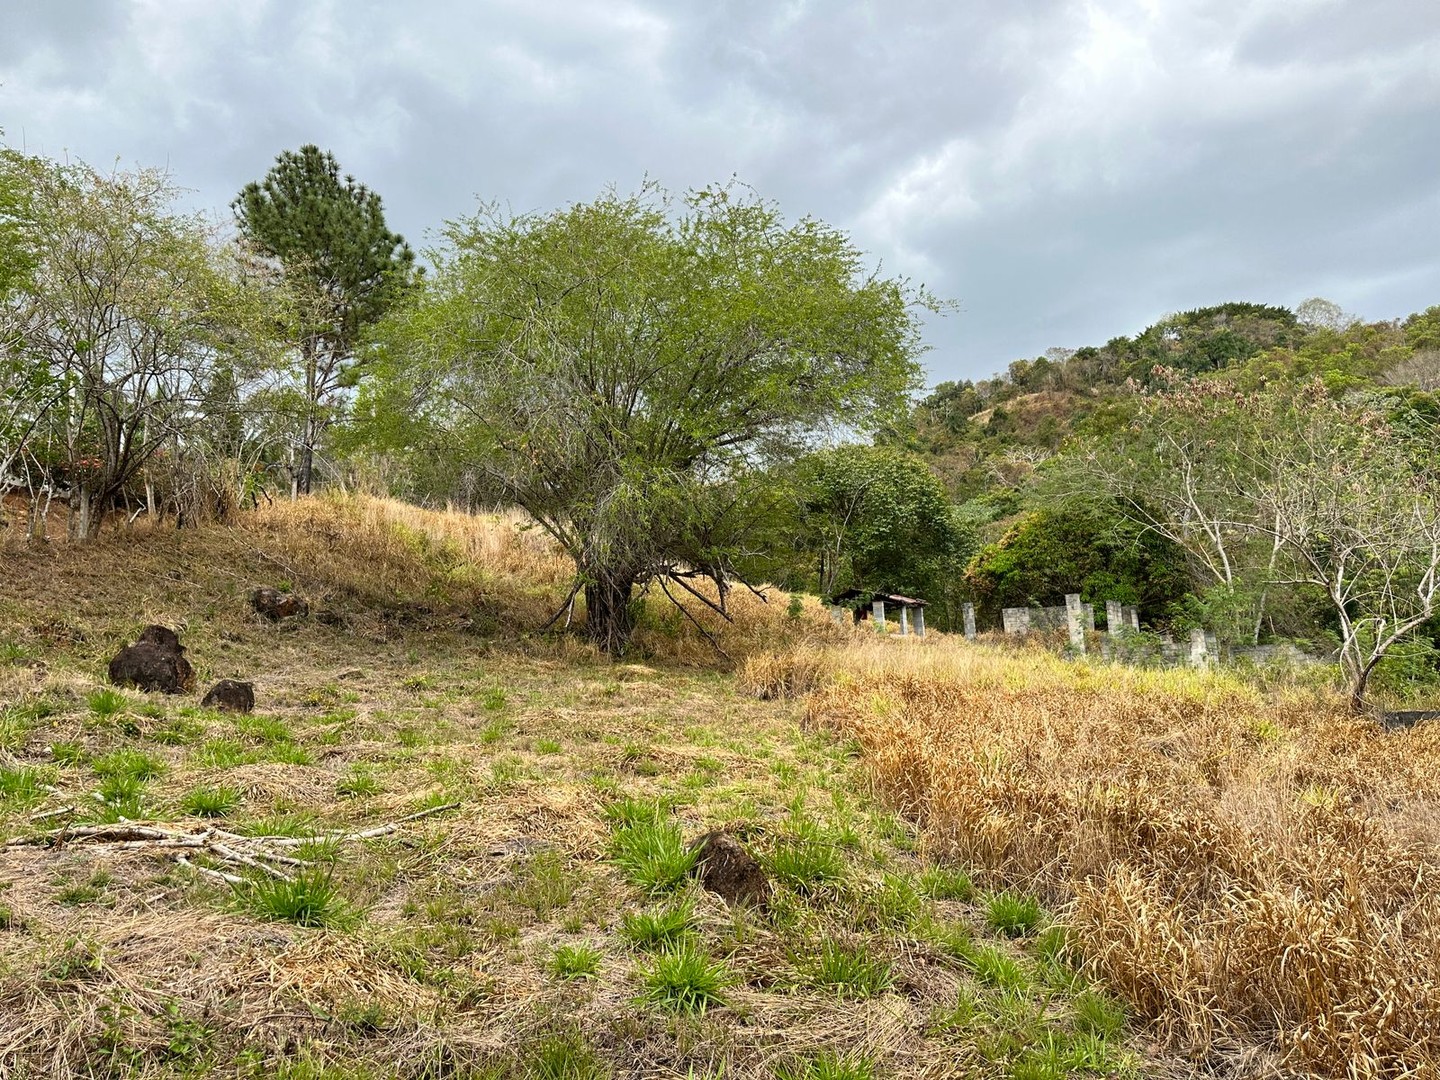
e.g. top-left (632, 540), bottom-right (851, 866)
top-left (0, 139), bottom-right (1440, 703)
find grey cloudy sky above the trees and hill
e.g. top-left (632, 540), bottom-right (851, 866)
top-left (0, 0), bottom-right (1440, 382)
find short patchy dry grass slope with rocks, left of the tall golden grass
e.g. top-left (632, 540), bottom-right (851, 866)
top-left (0, 500), bottom-right (1157, 1080)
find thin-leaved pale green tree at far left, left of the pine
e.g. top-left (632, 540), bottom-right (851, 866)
top-left (0, 163), bottom-right (258, 540)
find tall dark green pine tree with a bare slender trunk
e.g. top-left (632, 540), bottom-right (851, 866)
top-left (233, 145), bottom-right (416, 492)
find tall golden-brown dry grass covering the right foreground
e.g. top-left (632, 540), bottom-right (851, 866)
top-left (777, 638), bottom-right (1440, 1077)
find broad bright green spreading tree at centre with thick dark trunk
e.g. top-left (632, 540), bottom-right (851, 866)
top-left (367, 186), bottom-right (929, 652)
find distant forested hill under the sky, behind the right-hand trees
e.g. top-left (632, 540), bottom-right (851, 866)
top-left (888, 300), bottom-right (1440, 506)
